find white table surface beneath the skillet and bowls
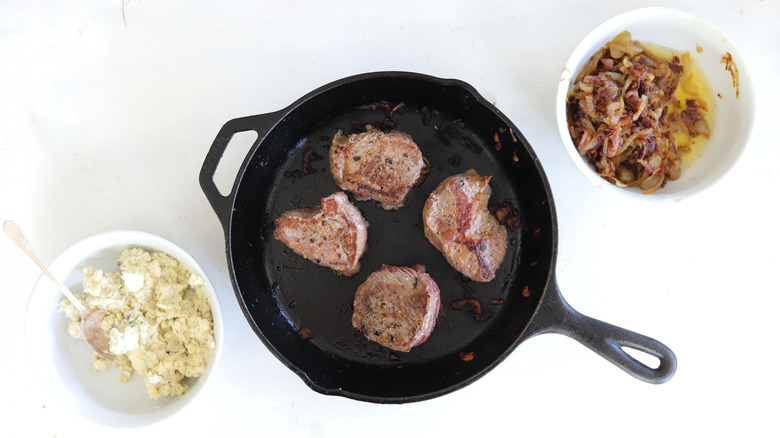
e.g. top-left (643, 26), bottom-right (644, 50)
top-left (0, 0), bottom-right (780, 437)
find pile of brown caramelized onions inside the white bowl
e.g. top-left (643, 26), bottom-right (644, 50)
top-left (567, 31), bottom-right (710, 194)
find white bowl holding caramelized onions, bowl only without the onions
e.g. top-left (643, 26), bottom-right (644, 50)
top-left (556, 7), bottom-right (755, 201)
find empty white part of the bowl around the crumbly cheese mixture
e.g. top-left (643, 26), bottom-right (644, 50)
top-left (25, 231), bottom-right (222, 427)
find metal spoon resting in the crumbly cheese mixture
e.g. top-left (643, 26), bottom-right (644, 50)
top-left (3, 220), bottom-right (115, 361)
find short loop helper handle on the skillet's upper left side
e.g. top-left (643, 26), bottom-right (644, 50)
top-left (199, 110), bottom-right (284, 229)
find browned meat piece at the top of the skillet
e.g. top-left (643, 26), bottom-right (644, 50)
top-left (329, 125), bottom-right (425, 210)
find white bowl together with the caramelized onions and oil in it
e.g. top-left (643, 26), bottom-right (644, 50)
top-left (556, 7), bottom-right (754, 200)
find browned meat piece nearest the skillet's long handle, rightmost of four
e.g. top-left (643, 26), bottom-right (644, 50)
top-left (423, 169), bottom-right (507, 282)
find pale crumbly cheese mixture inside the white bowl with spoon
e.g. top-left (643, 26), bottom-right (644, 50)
top-left (58, 248), bottom-right (216, 399)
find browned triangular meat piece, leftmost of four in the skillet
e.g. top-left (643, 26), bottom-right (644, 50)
top-left (274, 192), bottom-right (368, 276)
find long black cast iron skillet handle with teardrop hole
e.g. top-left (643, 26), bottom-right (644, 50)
top-left (531, 284), bottom-right (677, 384)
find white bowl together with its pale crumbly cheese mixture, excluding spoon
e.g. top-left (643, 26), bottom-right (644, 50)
top-left (25, 230), bottom-right (222, 427)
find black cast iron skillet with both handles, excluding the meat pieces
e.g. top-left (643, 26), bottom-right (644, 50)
top-left (200, 72), bottom-right (677, 403)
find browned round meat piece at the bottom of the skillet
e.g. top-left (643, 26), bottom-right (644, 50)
top-left (352, 265), bottom-right (441, 351)
